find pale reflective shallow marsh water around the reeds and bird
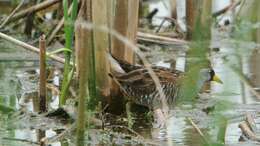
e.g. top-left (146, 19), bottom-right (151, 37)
top-left (0, 1), bottom-right (260, 146)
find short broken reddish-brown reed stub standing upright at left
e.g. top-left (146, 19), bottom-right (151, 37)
top-left (39, 35), bottom-right (47, 112)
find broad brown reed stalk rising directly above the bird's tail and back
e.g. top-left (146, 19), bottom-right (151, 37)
top-left (111, 0), bottom-right (139, 63)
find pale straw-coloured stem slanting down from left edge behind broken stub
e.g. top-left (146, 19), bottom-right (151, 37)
top-left (0, 32), bottom-right (65, 63)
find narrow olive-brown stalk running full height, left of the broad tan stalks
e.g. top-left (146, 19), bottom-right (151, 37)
top-left (75, 0), bottom-right (96, 146)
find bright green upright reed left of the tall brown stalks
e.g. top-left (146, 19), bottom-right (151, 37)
top-left (59, 0), bottom-right (78, 106)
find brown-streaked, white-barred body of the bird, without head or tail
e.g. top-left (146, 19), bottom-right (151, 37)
top-left (116, 67), bottom-right (183, 108)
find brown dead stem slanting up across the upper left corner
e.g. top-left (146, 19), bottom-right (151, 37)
top-left (6, 0), bottom-right (61, 24)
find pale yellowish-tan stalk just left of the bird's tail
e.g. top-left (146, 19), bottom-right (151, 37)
top-left (92, 0), bottom-right (110, 101)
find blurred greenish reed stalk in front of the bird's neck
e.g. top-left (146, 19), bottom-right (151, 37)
top-left (181, 0), bottom-right (212, 101)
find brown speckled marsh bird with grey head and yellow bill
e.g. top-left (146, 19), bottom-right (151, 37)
top-left (110, 58), bottom-right (222, 109)
